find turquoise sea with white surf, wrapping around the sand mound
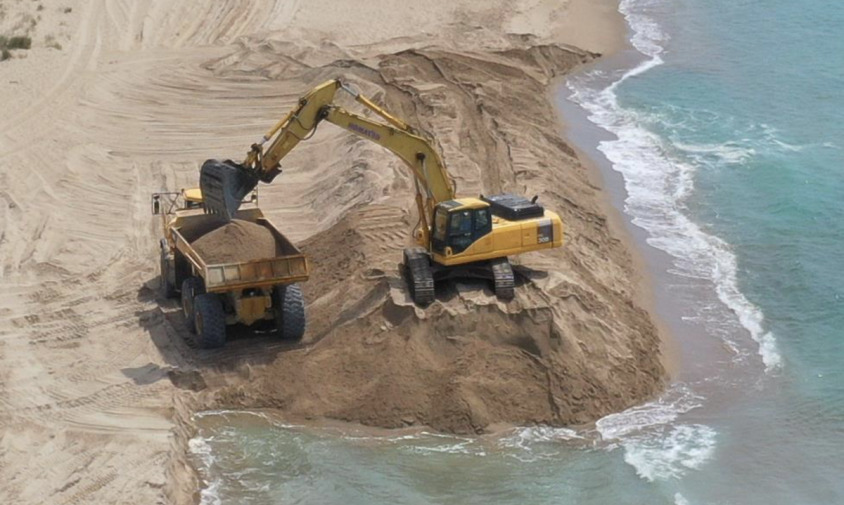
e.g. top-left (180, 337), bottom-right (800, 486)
top-left (191, 0), bottom-right (844, 505)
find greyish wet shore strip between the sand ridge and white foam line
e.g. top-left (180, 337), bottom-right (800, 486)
top-left (556, 0), bottom-right (775, 438)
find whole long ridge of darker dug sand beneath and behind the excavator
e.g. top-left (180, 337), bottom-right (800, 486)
top-left (196, 37), bottom-right (664, 433)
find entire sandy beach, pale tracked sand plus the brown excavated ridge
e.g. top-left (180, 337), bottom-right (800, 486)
top-left (0, 0), bottom-right (663, 504)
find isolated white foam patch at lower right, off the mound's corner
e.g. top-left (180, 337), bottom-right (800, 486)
top-left (622, 424), bottom-right (716, 482)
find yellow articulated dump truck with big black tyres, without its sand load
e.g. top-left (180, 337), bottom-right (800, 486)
top-left (152, 189), bottom-right (309, 349)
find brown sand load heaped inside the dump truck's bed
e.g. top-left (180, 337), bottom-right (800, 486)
top-left (192, 219), bottom-right (280, 264)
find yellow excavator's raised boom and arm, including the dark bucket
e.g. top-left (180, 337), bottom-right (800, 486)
top-left (200, 79), bottom-right (454, 243)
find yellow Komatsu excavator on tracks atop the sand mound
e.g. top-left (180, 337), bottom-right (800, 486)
top-left (200, 79), bottom-right (563, 305)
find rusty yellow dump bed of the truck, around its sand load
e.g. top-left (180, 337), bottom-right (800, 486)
top-left (172, 209), bottom-right (309, 293)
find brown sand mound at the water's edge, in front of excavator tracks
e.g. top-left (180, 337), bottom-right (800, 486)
top-left (208, 202), bottom-right (663, 433)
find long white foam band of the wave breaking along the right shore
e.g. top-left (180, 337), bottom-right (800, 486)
top-left (568, 0), bottom-right (782, 371)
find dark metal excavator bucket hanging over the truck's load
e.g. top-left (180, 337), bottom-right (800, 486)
top-left (199, 160), bottom-right (258, 221)
